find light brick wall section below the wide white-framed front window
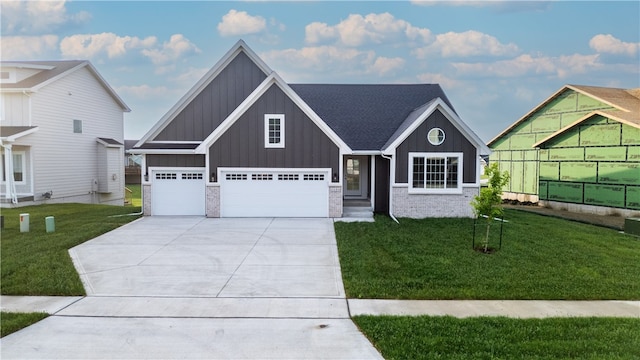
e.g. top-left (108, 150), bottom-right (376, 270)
top-left (392, 186), bottom-right (480, 219)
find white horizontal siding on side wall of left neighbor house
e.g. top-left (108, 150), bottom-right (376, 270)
top-left (16, 68), bottom-right (124, 204)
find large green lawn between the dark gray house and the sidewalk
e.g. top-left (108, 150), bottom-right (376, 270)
top-left (335, 210), bottom-right (640, 300)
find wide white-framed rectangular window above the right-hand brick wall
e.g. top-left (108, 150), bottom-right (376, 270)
top-left (408, 153), bottom-right (463, 194)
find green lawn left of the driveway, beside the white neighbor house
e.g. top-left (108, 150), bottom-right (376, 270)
top-left (0, 204), bottom-right (140, 296)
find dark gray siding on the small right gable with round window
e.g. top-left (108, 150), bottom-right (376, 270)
top-left (396, 110), bottom-right (477, 184)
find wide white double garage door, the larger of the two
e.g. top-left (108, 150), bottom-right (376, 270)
top-left (220, 169), bottom-right (331, 217)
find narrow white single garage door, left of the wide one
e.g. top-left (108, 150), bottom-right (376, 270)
top-left (151, 169), bottom-right (205, 215)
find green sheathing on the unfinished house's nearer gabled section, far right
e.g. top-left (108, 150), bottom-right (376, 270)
top-left (538, 116), bottom-right (640, 210)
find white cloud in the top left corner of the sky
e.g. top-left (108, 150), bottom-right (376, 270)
top-left (0, 0), bottom-right (91, 34)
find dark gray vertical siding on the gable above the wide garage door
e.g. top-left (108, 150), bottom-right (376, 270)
top-left (209, 84), bottom-right (341, 181)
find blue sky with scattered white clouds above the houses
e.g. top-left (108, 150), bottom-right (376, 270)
top-left (0, 0), bottom-right (640, 141)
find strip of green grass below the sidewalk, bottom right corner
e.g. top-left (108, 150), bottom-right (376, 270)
top-left (353, 316), bottom-right (640, 360)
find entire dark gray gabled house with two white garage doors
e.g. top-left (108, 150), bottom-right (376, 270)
top-left (132, 41), bottom-right (489, 218)
